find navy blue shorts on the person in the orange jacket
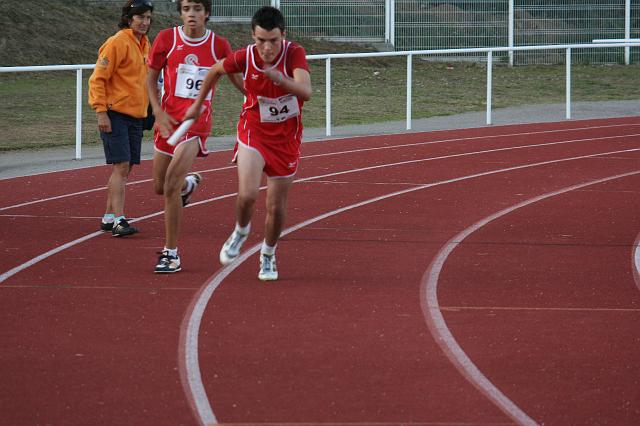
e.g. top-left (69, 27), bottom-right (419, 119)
top-left (100, 111), bottom-right (142, 164)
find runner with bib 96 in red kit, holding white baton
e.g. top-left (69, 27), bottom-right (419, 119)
top-left (147, 0), bottom-right (244, 273)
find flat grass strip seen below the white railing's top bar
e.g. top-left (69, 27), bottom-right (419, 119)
top-left (0, 58), bottom-right (640, 151)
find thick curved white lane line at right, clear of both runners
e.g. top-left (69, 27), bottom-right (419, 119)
top-left (420, 171), bottom-right (640, 425)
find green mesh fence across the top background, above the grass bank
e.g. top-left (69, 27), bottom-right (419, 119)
top-left (84, 0), bottom-right (640, 64)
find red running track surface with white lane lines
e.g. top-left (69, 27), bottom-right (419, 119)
top-left (0, 117), bottom-right (640, 425)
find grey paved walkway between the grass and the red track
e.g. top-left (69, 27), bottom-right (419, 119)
top-left (0, 100), bottom-right (640, 179)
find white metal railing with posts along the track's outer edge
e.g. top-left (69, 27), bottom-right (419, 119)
top-left (0, 39), bottom-right (640, 160)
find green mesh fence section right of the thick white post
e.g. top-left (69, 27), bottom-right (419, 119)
top-left (394, 0), bottom-right (640, 64)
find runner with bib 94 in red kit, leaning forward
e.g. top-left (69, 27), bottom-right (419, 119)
top-left (185, 6), bottom-right (311, 281)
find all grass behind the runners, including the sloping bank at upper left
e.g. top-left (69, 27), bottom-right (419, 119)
top-left (0, 0), bottom-right (640, 152)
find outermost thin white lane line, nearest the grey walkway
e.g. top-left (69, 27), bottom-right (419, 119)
top-left (0, 123), bottom-right (640, 211)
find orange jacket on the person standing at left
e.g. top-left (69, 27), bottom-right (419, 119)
top-left (89, 28), bottom-right (149, 118)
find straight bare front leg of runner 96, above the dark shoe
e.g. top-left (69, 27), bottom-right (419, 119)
top-left (163, 138), bottom-right (199, 249)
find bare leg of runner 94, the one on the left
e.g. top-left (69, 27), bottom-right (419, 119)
top-left (236, 145), bottom-right (264, 227)
